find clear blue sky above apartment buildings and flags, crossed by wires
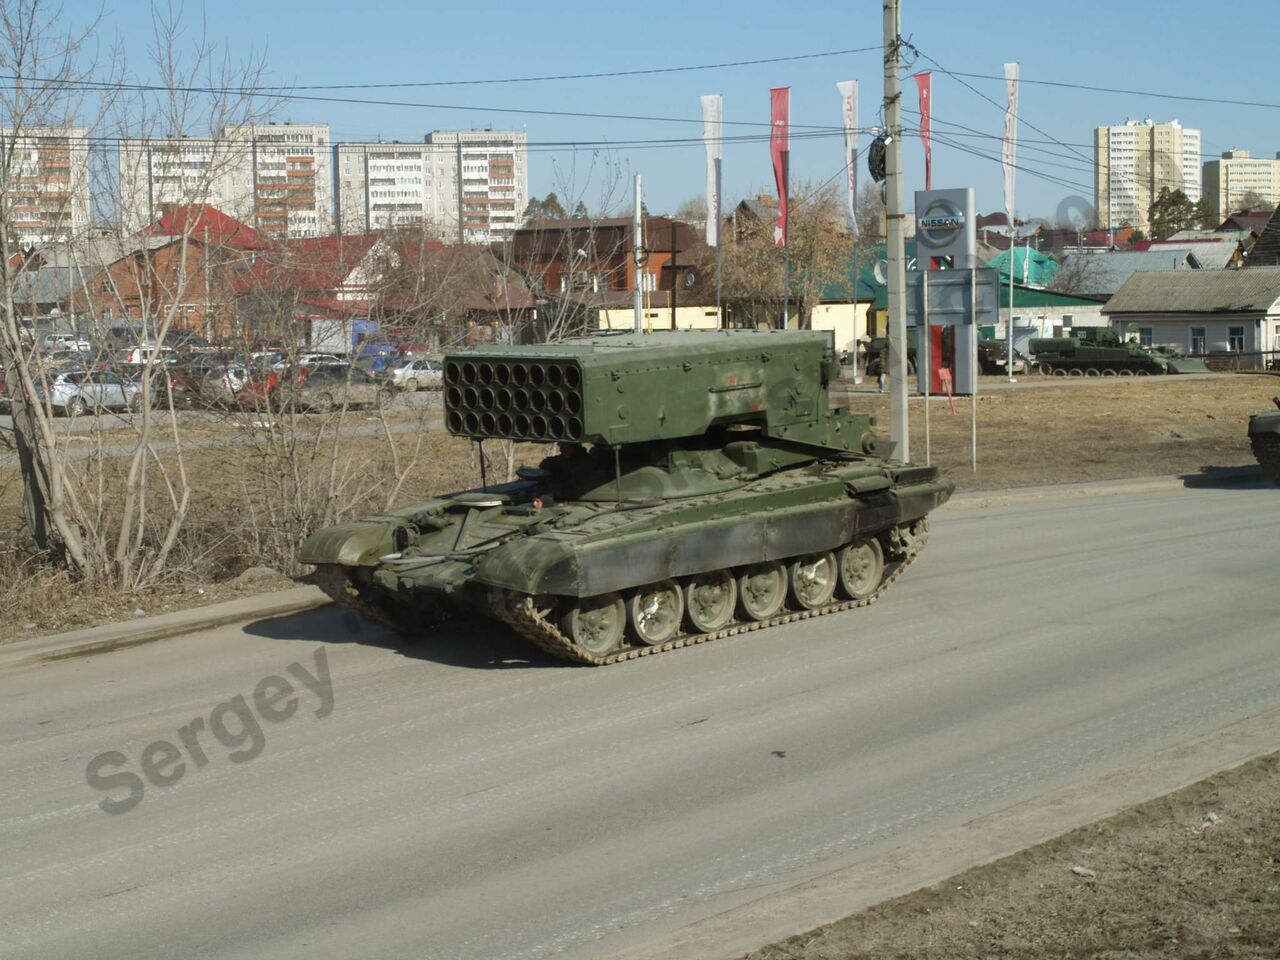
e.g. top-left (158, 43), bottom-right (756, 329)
top-left (65, 0), bottom-right (1280, 224)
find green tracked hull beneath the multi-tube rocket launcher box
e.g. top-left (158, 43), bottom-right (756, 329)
top-left (302, 461), bottom-right (954, 666)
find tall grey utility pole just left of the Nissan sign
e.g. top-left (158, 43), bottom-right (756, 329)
top-left (884, 0), bottom-right (911, 462)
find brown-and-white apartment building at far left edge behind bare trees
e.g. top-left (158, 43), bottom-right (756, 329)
top-left (0, 127), bottom-right (90, 247)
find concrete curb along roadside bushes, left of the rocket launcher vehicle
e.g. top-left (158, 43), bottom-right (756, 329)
top-left (0, 586), bottom-right (330, 669)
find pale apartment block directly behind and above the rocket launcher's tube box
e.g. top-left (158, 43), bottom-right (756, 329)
top-left (334, 131), bottom-right (529, 243)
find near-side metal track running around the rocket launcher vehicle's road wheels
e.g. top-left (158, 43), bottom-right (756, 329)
top-left (489, 520), bottom-right (929, 667)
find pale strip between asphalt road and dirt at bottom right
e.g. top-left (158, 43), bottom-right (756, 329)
top-left (609, 710), bottom-right (1280, 960)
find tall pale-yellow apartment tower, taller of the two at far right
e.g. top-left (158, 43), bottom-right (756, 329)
top-left (1093, 116), bottom-right (1201, 230)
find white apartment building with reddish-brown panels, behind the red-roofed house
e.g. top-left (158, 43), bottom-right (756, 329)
top-left (119, 123), bottom-right (333, 238)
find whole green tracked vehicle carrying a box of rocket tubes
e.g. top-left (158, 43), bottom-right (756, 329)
top-left (301, 330), bottom-right (954, 666)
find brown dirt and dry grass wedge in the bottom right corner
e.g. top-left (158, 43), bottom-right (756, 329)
top-left (749, 754), bottom-right (1280, 960)
